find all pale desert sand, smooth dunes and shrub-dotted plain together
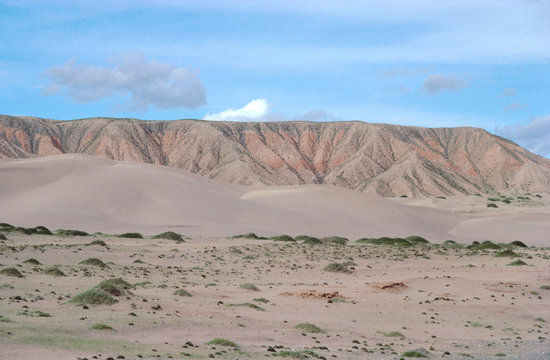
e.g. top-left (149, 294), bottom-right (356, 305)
top-left (0, 155), bottom-right (550, 359)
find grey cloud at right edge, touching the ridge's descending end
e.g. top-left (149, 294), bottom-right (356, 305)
top-left (495, 115), bottom-right (550, 157)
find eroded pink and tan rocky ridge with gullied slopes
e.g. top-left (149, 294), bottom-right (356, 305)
top-left (0, 116), bottom-right (550, 196)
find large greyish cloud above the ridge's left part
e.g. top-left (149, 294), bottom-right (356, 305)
top-left (43, 54), bottom-right (206, 110)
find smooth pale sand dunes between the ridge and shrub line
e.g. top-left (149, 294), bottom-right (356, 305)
top-left (0, 154), bottom-right (550, 245)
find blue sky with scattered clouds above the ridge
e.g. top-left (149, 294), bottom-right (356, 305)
top-left (0, 0), bottom-right (550, 156)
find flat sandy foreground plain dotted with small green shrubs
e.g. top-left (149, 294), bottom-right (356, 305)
top-left (0, 233), bottom-right (550, 359)
